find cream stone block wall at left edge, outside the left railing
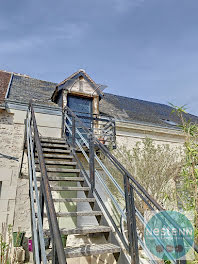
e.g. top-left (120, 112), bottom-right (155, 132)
top-left (0, 110), bottom-right (24, 233)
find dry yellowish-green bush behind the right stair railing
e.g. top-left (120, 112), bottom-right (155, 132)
top-left (104, 138), bottom-right (183, 207)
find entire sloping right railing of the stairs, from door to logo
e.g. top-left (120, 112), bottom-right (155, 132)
top-left (64, 107), bottom-right (198, 264)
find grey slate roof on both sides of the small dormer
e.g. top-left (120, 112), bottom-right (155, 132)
top-left (5, 72), bottom-right (198, 128)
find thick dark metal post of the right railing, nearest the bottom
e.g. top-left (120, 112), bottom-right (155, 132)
top-left (124, 175), bottom-right (139, 264)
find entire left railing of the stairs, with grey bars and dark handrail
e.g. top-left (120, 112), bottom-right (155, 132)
top-left (25, 102), bottom-right (66, 264)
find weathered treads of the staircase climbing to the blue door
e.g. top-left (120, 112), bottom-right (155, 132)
top-left (37, 138), bottom-right (120, 259)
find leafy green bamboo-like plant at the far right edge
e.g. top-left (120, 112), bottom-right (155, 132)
top-left (171, 105), bottom-right (198, 243)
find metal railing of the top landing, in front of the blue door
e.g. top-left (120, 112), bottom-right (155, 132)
top-left (63, 109), bottom-right (116, 148)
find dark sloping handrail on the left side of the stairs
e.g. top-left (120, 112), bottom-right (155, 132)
top-left (29, 101), bottom-right (66, 264)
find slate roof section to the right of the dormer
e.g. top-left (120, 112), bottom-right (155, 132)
top-left (100, 93), bottom-right (198, 127)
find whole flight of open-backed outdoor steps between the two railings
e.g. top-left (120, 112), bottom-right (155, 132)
top-left (35, 138), bottom-right (121, 263)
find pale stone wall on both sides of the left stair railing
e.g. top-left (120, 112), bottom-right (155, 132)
top-left (0, 109), bottom-right (62, 237)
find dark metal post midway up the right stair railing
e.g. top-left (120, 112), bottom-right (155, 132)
top-left (89, 134), bottom-right (95, 192)
